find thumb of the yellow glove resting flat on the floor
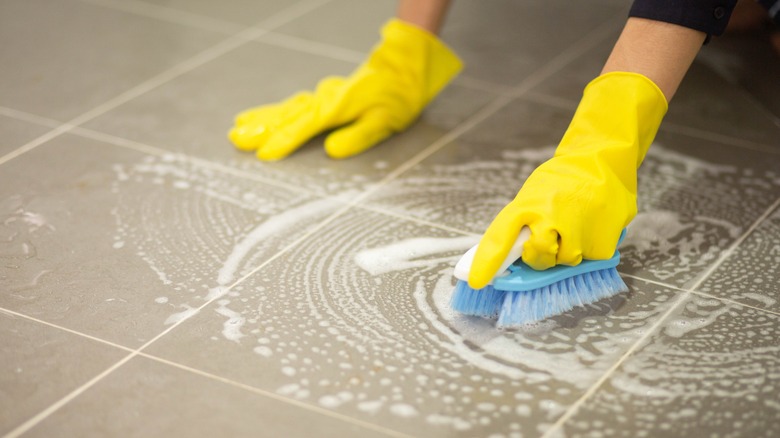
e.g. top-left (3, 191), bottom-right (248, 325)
top-left (325, 110), bottom-right (393, 158)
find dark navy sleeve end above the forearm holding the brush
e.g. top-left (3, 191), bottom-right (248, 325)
top-left (628, 0), bottom-right (737, 39)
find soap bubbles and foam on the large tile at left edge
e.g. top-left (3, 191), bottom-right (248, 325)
top-left (111, 154), bottom-right (322, 312)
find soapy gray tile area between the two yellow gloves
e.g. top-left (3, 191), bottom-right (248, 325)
top-left (367, 97), bottom-right (574, 234)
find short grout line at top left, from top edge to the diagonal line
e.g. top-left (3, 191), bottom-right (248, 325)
top-left (81, 0), bottom-right (244, 35)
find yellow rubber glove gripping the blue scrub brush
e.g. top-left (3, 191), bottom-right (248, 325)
top-left (469, 72), bottom-right (668, 289)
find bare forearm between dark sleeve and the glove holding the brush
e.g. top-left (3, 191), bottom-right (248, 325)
top-left (601, 17), bottom-right (706, 101)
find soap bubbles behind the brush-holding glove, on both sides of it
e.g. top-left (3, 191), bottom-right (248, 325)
top-left (371, 139), bottom-right (780, 286)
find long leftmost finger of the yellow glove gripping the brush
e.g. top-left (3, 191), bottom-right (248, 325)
top-left (469, 204), bottom-right (523, 289)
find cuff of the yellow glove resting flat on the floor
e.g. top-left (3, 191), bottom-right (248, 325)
top-left (375, 18), bottom-right (463, 105)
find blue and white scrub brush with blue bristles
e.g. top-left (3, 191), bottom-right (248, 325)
top-left (450, 227), bottom-right (628, 328)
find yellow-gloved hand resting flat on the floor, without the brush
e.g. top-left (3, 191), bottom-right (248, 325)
top-left (228, 19), bottom-right (462, 160)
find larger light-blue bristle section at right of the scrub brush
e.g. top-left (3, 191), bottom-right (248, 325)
top-left (496, 268), bottom-right (628, 328)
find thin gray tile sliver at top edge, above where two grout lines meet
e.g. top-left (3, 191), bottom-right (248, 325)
top-left (134, 0), bottom-right (292, 25)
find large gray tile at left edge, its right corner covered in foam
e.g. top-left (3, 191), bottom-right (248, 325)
top-left (0, 135), bottom-right (338, 346)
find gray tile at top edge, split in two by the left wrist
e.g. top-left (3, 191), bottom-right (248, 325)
top-left (279, 0), bottom-right (626, 85)
